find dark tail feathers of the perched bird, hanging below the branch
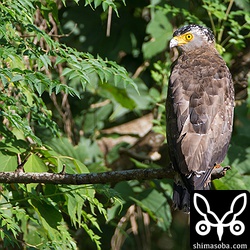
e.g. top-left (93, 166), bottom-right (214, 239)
top-left (173, 169), bottom-right (212, 213)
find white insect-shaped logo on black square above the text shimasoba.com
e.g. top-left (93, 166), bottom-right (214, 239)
top-left (193, 193), bottom-right (247, 241)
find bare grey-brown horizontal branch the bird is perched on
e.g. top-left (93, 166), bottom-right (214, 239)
top-left (0, 166), bottom-right (230, 185)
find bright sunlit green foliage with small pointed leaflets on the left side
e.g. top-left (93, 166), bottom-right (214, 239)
top-left (0, 1), bottom-right (133, 249)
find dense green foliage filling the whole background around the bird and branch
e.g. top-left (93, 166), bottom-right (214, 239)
top-left (0, 0), bottom-right (250, 249)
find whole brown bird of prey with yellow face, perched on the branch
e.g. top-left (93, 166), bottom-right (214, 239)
top-left (166, 24), bottom-right (234, 212)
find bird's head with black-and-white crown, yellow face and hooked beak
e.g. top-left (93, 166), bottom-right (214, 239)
top-left (169, 24), bottom-right (215, 51)
